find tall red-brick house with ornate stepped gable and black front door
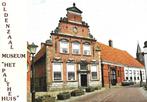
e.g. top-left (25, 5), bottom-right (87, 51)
top-left (35, 4), bottom-right (101, 91)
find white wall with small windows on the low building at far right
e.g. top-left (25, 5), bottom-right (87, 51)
top-left (124, 67), bottom-right (146, 82)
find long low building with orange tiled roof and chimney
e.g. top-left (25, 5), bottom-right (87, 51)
top-left (97, 40), bottom-right (145, 86)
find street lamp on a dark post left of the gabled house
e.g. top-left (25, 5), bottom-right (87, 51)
top-left (28, 43), bottom-right (38, 102)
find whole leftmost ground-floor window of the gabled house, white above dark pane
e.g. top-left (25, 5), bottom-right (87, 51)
top-left (53, 63), bottom-right (62, 81)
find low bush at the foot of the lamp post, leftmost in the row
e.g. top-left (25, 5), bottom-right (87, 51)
top-left (35, 95), bottom-right (55, 102)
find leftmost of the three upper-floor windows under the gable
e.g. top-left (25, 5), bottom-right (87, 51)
top-left (60, 40), bottom-right (69, 53)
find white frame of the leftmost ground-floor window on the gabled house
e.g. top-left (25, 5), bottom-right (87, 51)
top-left (52, 62), bottom-right (63, 81)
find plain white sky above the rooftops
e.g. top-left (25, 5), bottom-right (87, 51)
top-left (26, 0), bottom-right (147, 57)
